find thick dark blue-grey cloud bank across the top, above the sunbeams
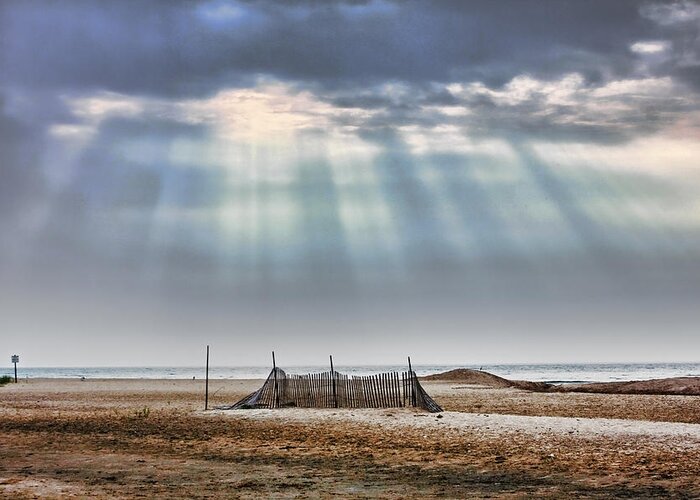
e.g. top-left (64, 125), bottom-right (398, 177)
top-left (0, 0), bottom-right (685, 96)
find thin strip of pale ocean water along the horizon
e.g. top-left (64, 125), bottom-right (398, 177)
top-left (0, 363), bottom-right (700, 384)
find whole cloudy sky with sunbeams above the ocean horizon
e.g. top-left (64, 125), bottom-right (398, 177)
top-left (0, 0), bottom-right (700, 366)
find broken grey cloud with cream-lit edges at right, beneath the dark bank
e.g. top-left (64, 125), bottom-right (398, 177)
top-left (322, 75), bottom-right (700, 146)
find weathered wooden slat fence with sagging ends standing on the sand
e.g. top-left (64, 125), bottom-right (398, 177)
top-left (220, 367), bottom-right (442, 413)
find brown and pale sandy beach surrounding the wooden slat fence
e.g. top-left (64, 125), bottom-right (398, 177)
top-left (0, 379), bottom-right (700, 498)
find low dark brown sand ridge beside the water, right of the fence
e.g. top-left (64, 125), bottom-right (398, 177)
top-left (421, 368), bottom-right (700, 396)
